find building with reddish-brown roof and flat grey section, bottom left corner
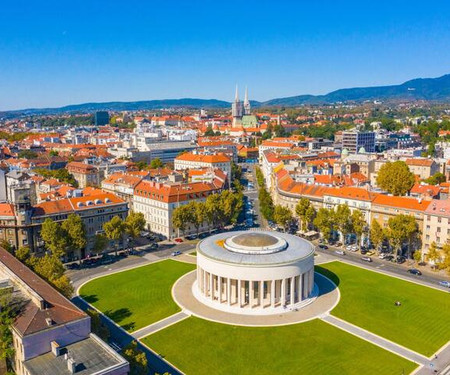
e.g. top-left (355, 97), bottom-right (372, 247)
top-left (0, 248), bottom-right (130, 375)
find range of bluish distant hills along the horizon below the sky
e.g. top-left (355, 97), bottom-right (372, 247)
top-left (0, 74), bottom-right (450, 117)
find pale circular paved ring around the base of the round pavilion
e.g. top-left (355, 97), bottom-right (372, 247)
top-left (172, 271), bottom-right (340, 327)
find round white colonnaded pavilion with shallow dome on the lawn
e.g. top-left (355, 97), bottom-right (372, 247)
top-left (192, 231), bottom-right (318, 314)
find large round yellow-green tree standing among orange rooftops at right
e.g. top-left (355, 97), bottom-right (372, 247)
top-left (377, 161), bottom-right (415, 195)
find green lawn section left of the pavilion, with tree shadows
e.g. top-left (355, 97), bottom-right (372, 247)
top-left (80, 260), bottom-right (195, 332)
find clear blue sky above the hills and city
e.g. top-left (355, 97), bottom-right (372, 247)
top-left (0, 0), bottom-right (450, 110)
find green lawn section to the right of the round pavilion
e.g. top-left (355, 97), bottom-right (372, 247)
top-left (316, 262), bottom-right (450, 356)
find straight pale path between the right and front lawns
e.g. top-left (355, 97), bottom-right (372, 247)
top-left (321, 315), bottom-right (430, 365)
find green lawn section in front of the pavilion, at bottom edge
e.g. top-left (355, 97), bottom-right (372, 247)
top-left (142, 317), bottom-right (415, 375)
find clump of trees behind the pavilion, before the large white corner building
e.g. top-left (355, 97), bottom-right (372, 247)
top-left (172, 190), bottom-right (243, 234)
